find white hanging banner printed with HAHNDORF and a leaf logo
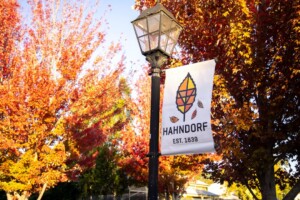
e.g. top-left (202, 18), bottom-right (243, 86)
top-left (161, 60), bottom-right (216, 155)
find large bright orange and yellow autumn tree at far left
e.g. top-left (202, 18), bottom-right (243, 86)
top-left (0, 0), bottom-right (128, 199)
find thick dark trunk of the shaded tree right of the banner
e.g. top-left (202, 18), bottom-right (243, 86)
top-left (258, 160), bottom-right (277, 200)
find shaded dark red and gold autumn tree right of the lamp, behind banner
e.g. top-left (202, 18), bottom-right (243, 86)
top-left (136, 0), bottom-right (300, 200)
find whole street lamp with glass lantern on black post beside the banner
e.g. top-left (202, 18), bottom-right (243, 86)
top-left (132, 2), bottom-right (182, 200)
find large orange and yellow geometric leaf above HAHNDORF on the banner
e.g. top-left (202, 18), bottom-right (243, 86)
top-left (176, 73), bottom-right (197, 121)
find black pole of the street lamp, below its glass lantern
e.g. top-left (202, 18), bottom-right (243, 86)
top-left (147, 52), bottom-right (167, 200)
